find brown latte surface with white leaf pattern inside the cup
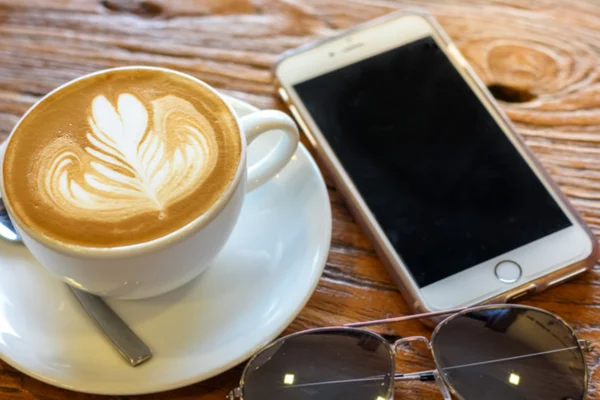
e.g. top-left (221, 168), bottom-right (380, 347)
top-left (3, 69), bottom-right (242, 248)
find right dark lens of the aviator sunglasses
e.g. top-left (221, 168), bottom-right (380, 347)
top-left (432, 307), bottom-right (586, 400)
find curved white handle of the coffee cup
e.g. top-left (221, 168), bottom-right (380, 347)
top-left (240, 110), bottom-right (299, 192)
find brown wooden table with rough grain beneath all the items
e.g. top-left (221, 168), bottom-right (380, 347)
top-left (0, 0), bottom-right (600, 400)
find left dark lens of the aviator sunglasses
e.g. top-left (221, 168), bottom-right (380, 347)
top-left (243, 329), bottom-right (394, 400)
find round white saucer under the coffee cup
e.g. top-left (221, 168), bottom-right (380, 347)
top-left (0, 95), bottom-right (331, 395)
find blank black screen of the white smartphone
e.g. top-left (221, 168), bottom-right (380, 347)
top-left (294, 37), bottom-right (571, 287)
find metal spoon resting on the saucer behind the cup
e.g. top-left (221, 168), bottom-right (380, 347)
top-left (0, 198), bottom-right (152, 367)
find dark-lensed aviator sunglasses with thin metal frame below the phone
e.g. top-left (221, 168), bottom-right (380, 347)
top-left (228, 304), bottom-right (593, 400)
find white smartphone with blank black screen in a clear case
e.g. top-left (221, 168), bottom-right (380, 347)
top-left (275, 13), bottom-right (598, 311)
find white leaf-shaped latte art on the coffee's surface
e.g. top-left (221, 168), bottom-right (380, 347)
top-left (37, 93), bottom-right (217, 220)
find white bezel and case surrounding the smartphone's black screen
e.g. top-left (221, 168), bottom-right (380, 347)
top-left (275, 13), bottom-right (597, 311)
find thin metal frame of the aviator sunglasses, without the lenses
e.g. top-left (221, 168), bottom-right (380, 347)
top-left (226, 304), bottom-right (594, 400)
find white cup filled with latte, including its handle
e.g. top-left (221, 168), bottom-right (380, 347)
top-left (0, 66), bottom-right (298, 299)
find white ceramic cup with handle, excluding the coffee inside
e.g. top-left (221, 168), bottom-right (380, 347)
top-left (0, 67), bottom-right (298, 299)
